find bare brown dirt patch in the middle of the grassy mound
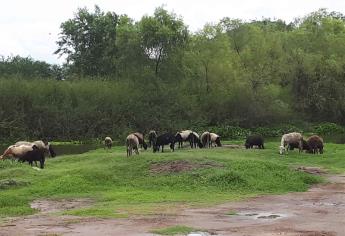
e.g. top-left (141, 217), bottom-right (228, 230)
top-left (150, 160), bottom-right (223, 173)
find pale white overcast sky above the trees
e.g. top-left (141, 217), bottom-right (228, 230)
top-left (0, 0), bottom-right (345, 63)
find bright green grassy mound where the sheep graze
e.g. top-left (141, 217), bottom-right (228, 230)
top-left (0, 142), bottom-right (345, 217)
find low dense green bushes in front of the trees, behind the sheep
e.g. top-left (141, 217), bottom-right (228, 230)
top-left (0, 79), bottom-right (344, 141)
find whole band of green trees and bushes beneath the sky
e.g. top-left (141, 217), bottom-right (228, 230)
top-left (0, 6), bottom-right (345, 139)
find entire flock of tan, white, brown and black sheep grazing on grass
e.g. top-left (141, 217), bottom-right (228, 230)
top-left (0, 130), bottom-right (324, 169)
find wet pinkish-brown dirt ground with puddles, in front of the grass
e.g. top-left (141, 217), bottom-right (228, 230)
top-left (0, 169), bottom-right (345, 236)
